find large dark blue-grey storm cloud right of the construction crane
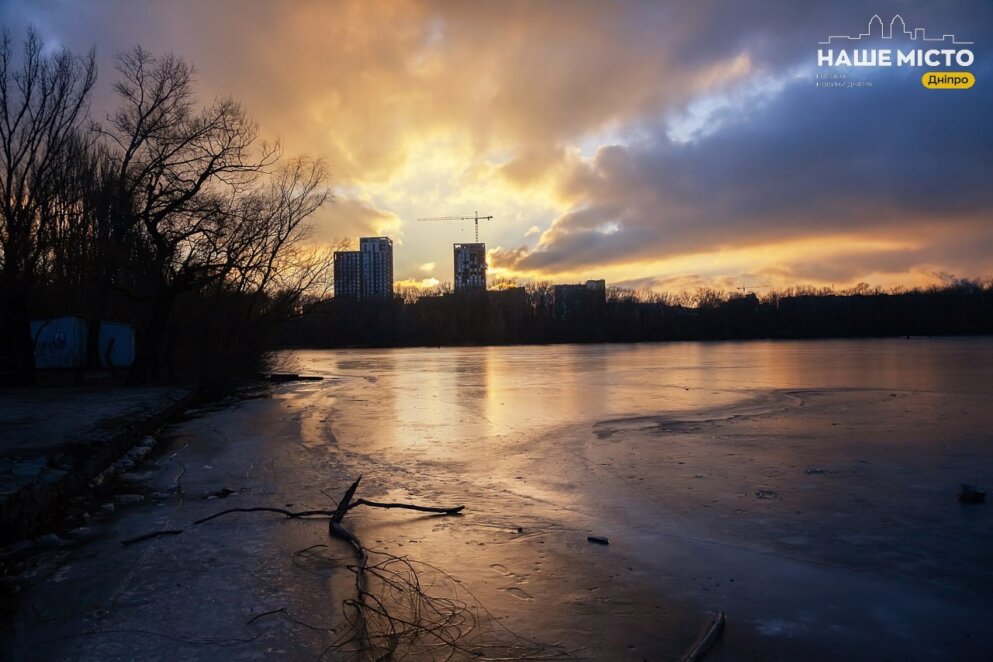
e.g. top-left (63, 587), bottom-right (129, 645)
top-left (496, 2), bottom-right (993, 277)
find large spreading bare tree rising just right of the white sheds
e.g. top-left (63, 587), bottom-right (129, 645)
top-left (101, 46), bottom-right (290, 380)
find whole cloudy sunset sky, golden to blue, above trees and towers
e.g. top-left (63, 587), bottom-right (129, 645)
top-left (0, 0), bottom-right (993, 291)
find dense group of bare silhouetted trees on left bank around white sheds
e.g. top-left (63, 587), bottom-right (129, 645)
top-left (0, 30), bottom-right (334, 383)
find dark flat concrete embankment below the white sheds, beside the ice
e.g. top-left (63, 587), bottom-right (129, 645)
top-left (0, 388), bottom-right (194, 544)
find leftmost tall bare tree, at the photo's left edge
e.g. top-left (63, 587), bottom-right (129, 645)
top-left (0, 29), bottom-right (97, 382)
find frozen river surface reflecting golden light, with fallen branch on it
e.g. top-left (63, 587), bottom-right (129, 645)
top-left (7, 338), bottom-right (993, 660)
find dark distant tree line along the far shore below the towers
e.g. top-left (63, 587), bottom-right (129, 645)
top-left (276, 280), bottom-right (993, 347)
